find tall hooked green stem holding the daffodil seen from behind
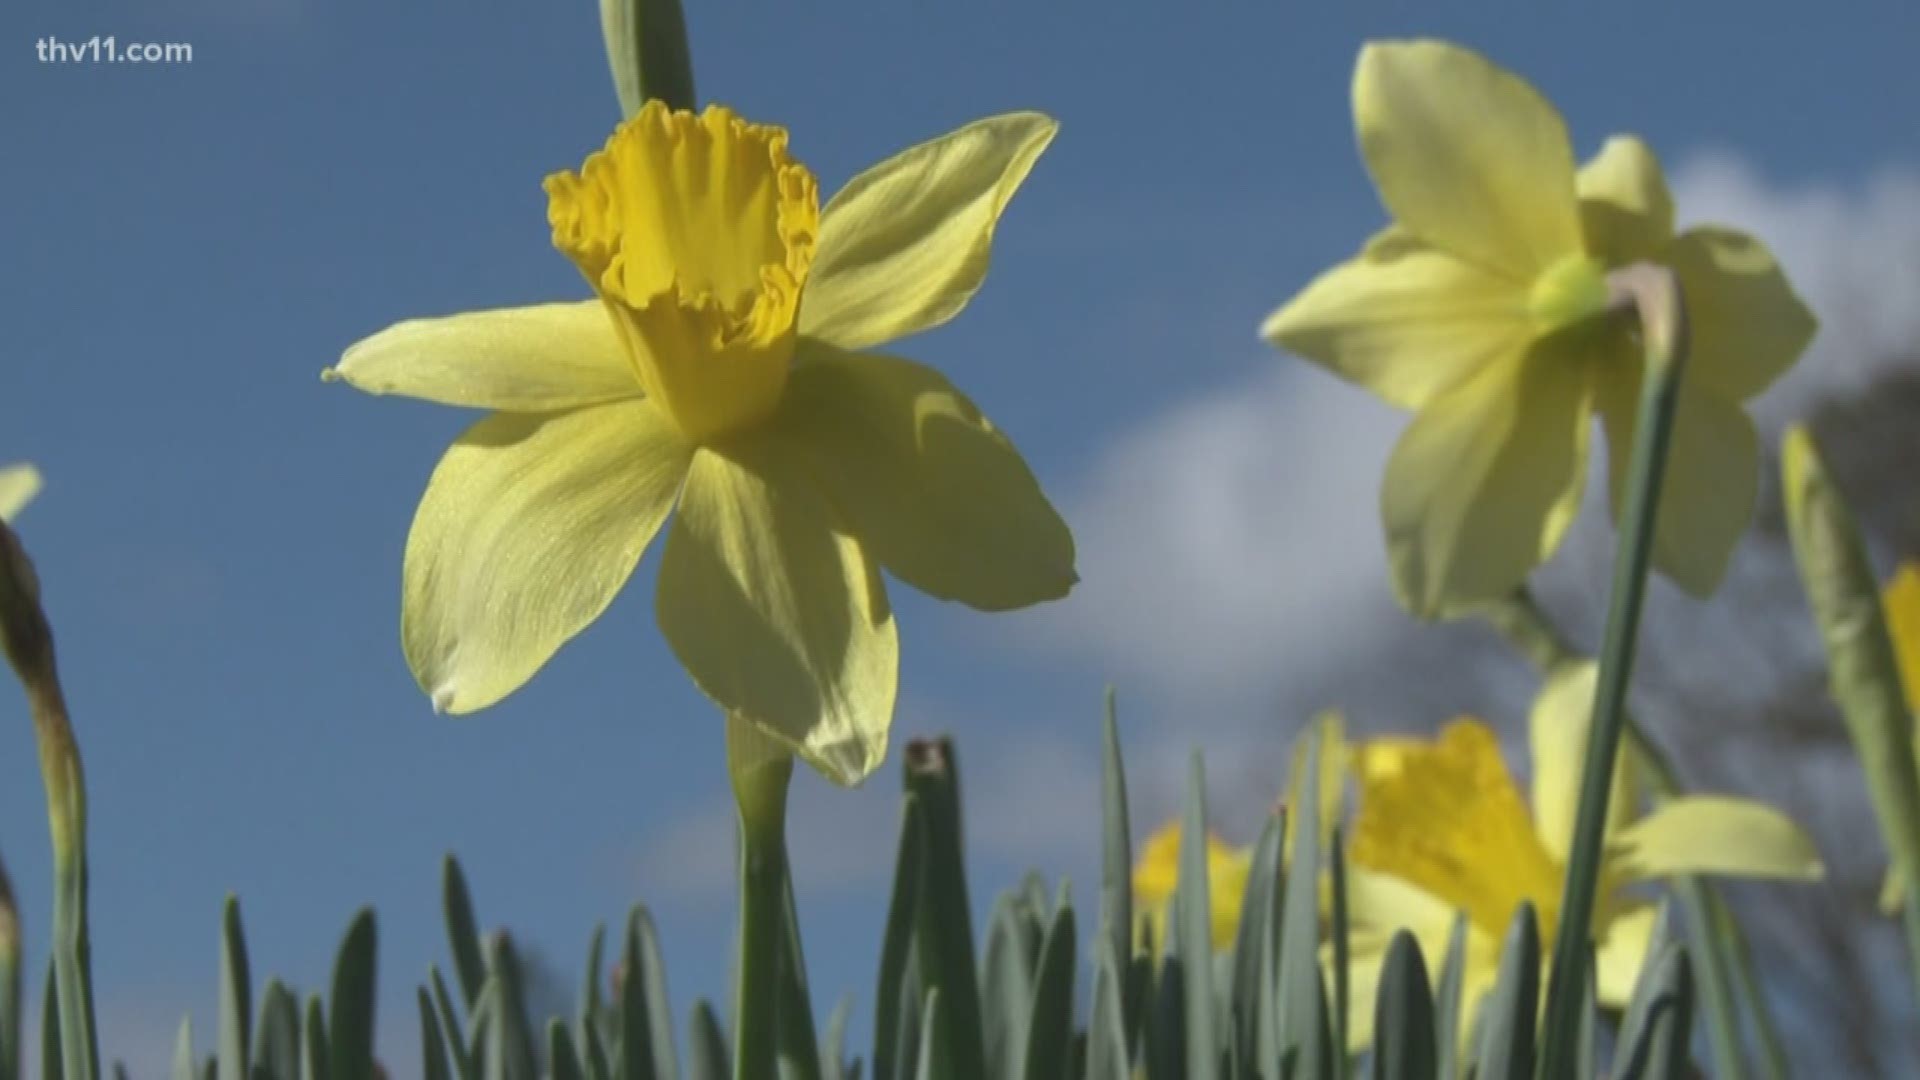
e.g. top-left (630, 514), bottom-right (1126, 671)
top-left (1540, 265), bottom-right (1686, 1076)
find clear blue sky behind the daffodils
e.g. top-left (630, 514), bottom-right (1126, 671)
top-left (0, 0), bottom-right (1920, 1074)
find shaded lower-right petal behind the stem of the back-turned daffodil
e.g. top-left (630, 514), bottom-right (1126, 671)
top-left (1599, 376), bottom-right (1761, 598)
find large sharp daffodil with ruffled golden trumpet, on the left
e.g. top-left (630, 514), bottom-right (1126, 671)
top-left (328, 102), bottom-right (1075, 784)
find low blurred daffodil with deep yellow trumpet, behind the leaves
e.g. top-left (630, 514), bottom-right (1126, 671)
top-left (1348, 663), bottom-right (1822, 1043)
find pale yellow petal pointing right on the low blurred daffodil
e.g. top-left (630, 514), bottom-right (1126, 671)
top-left (1607, 796), bottom-right (1822, 880)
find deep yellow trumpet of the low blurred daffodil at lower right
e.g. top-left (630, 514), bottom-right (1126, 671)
top-left (1354, 719), bottom-right (1561, 940)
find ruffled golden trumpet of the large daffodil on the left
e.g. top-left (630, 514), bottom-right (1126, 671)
top-left (545, 100), bottom-right (820, 440)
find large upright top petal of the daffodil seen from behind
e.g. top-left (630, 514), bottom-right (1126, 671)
top-left (1354, 40), bottom-right (1582, 282)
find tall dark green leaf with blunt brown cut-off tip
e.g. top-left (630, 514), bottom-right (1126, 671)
top-left (906, 738), bottom-right (987, 1078)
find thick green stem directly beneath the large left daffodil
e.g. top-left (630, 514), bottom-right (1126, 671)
top-left (726, 715), bottom-right (793, 1080)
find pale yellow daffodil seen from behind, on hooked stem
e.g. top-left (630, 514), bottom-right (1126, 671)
top-left (1261, 40), bottom-right (1814, 617)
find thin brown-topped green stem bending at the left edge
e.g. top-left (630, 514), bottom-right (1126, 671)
top-left (0, 525), bottom-right (100, 1080)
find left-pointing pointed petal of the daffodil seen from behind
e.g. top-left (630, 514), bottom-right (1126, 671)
top-left (1260, 231), bottom-right (1532, 409)
